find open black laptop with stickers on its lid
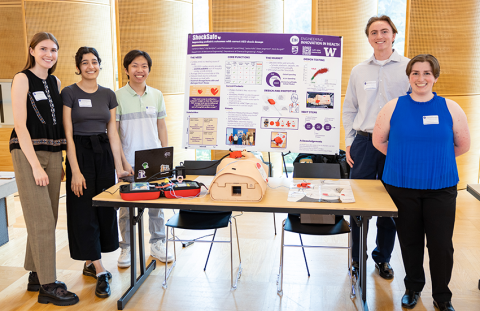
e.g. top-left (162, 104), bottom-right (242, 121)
top-left (134, 147), bottom-right (173, 182)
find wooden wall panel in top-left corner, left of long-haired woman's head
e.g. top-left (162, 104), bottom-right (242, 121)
top-left (0, 0), bottom-right (27, 79)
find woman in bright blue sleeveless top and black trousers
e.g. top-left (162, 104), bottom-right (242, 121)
top-left (372, 54), bottom-right (470, 310)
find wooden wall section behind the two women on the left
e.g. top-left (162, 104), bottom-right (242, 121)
top-left (0, 0), bottom-right (115, 171)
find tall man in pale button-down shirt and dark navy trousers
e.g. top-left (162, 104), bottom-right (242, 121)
top-left (343, 15), bottom-right (410, 279)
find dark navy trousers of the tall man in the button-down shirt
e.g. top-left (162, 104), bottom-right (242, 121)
top-left (350, 135), bottom-right (397, 263)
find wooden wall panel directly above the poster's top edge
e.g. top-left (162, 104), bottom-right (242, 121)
top-left (210, 0), bottom-right (283, 33)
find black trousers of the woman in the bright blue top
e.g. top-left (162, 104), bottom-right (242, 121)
top-left (385, 184), bottom-right (457, 302)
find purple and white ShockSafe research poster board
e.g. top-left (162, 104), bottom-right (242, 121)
top-left (182, 33), bottom-right (343, 154)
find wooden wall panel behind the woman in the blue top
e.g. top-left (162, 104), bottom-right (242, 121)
top-left (405, 0), bottom-right (480, 188)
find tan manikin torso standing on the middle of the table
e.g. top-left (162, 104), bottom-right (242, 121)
top-left (210, 151), bottom-right (268, 202)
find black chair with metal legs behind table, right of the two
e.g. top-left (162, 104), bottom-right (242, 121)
top-left (277, 163), bottom-right (356, 298)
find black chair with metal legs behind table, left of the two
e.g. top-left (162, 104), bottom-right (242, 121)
top-left (163, 161), bottom-right (242, 289)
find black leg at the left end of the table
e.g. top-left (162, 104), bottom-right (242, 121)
top-left (117, 207), bottom-right (156, 310)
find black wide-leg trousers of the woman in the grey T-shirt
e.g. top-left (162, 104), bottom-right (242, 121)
top-left (66, 134), bottom-right (119, 261)
